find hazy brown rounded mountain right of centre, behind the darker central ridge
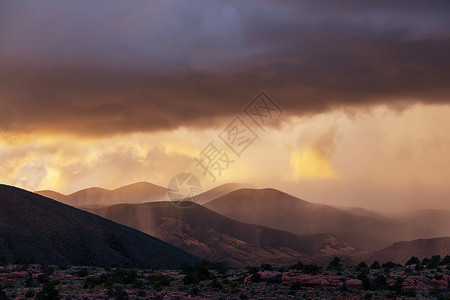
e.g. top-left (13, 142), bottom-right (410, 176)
top-left (205, 189), bottom-right (433, 251)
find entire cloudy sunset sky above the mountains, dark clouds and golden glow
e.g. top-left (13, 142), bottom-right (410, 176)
top-left (0, 0), bottom-right (450, 211)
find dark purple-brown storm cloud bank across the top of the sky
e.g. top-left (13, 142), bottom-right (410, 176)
top-left (0, 1), bottom-right (450, 135)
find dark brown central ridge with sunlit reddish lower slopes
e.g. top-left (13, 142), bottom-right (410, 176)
top-left (90, 202), bottom-right (353, 267)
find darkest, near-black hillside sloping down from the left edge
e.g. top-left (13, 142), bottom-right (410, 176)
top-left (0, 185), bottom-right (198, 268)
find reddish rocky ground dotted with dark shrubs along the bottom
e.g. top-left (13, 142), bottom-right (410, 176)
top-left (0, 259), bottom-right (450, 299)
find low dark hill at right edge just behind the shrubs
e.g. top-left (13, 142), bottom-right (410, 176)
top-left (372, 237), bottom-right (450, 264)
